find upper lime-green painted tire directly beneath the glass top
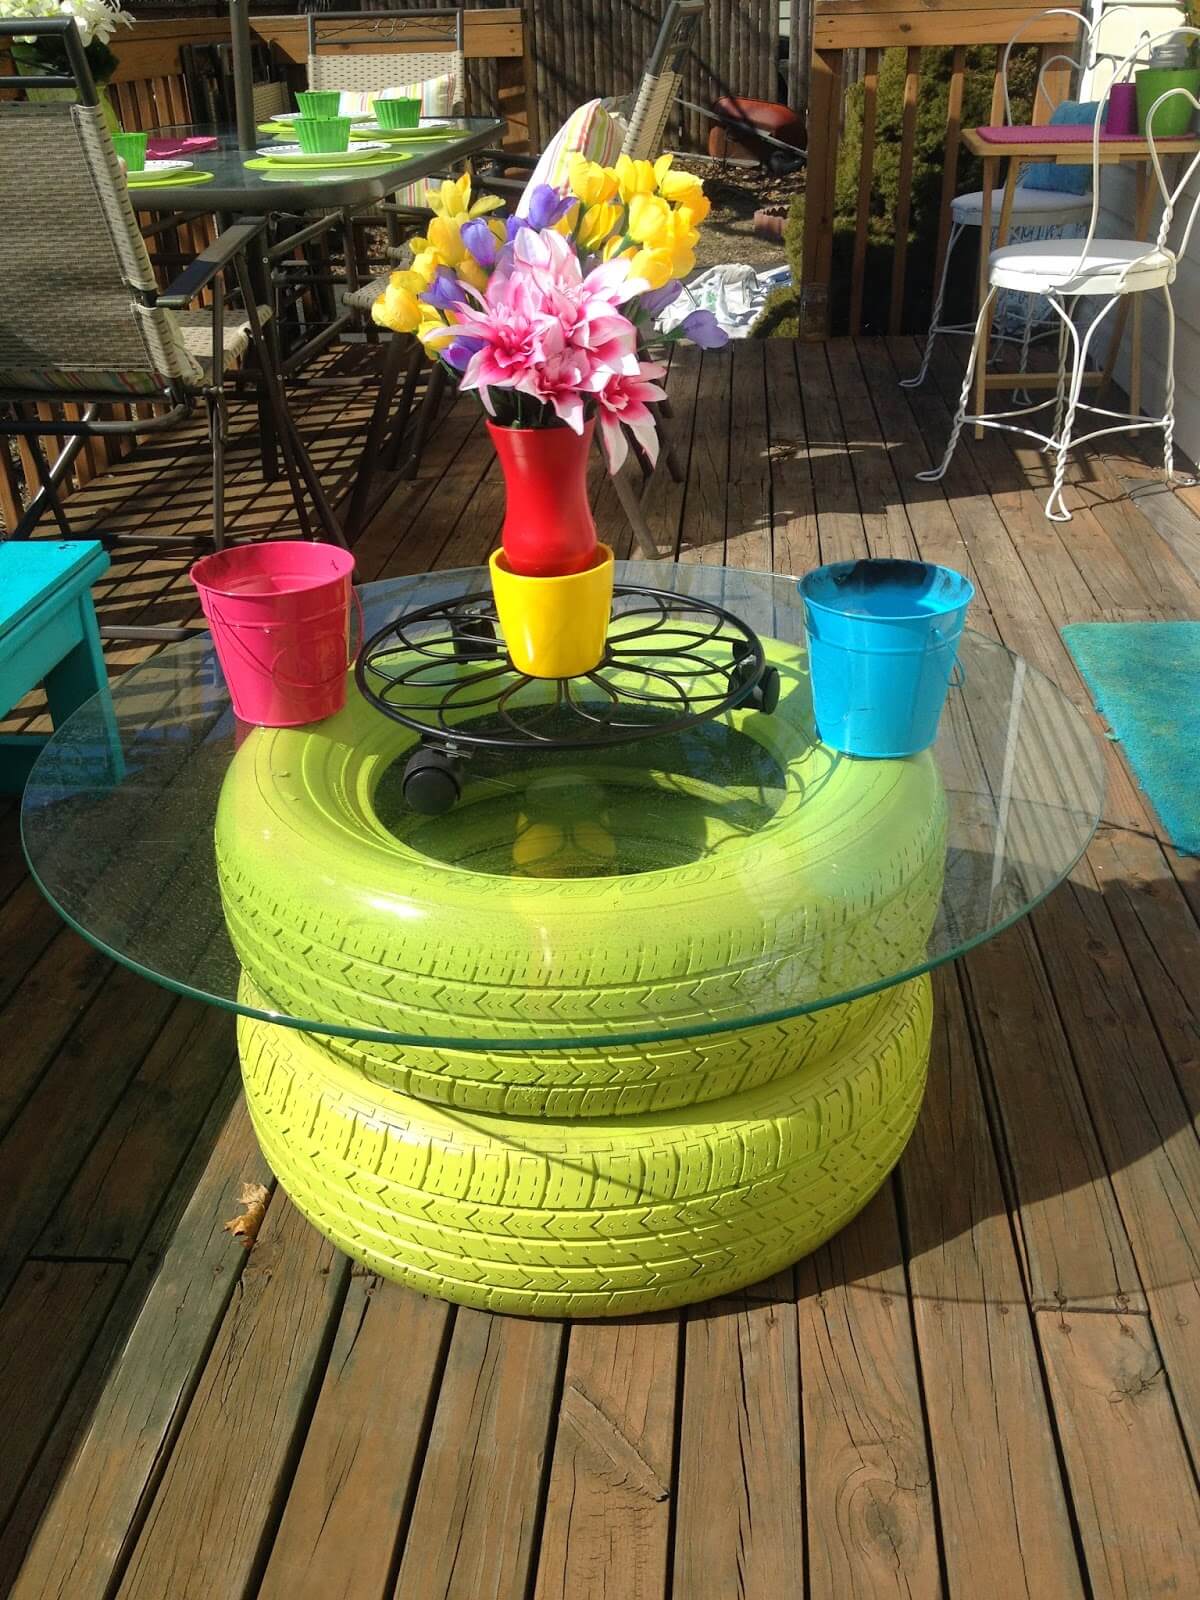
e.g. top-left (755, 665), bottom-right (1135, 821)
top-left (216, 640), bottom-right (946, 1117)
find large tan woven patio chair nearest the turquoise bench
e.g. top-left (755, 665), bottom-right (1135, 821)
top-left (0, 19), bottom-right (341, 604)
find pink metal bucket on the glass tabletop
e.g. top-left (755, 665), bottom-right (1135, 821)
top-left (192, 539), bottom-right (358, 728)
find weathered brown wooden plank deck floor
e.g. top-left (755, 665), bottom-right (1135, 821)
top-left (0, 331), bottom-right (1200, 1600)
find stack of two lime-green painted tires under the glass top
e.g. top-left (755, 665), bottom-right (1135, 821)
top-left (216, 642), bottom-right (946, 1317)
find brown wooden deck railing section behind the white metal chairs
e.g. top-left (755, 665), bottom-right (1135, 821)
top-left (800, 0), bottom-right (1075, 339)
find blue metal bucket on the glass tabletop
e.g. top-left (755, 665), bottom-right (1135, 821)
top-left (798, 562), bottom-right (974, 757)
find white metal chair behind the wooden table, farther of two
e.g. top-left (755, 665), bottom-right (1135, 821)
top-left (901, 5), bottom-right (1134, 389)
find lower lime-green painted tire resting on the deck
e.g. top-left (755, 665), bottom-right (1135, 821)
top-left (238, 978), bottom-right (931, 1317)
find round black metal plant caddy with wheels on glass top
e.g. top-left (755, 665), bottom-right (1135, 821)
top-left (355, 584), bottom-right (790, 816)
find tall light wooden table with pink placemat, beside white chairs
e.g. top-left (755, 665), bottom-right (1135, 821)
top-left (962, 126), bottom-right (1200, 437)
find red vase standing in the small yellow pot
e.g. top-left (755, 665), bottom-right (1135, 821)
top-left (488, 421), bottom-right (598, 578)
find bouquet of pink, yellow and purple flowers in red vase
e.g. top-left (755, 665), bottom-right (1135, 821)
top-left (373, 155), bottom-right (726, 472)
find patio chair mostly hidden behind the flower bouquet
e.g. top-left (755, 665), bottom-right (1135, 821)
top-left (339, 0), bottom-right (707, 555)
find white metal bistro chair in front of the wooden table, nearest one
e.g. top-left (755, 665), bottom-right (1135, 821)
top-left (917, 27), bottom-right (1200, 522)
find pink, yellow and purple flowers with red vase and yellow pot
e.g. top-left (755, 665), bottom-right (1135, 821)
top-left (373, 155), bottom-right (726, 678)
